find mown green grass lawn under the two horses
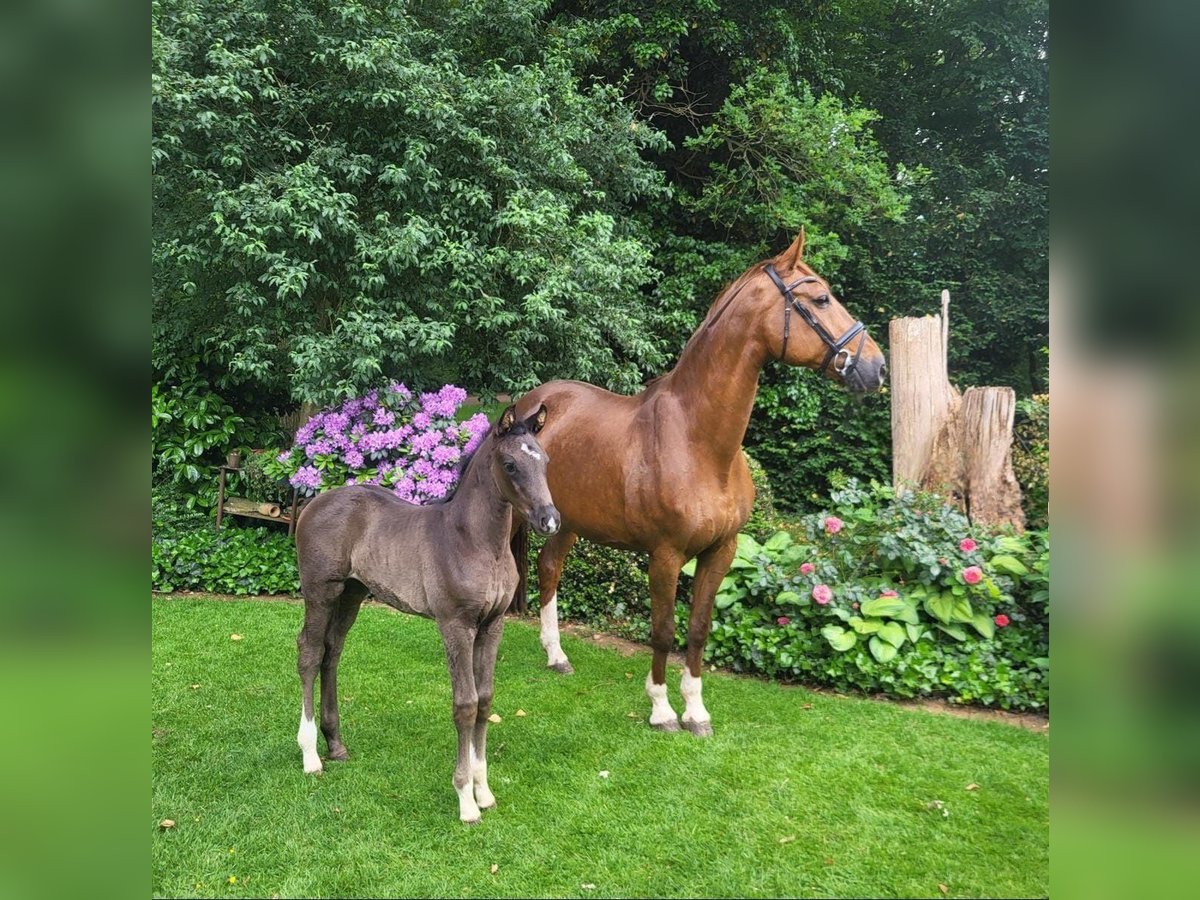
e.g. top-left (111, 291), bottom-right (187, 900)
top-left (150, 598), bottom-right (1049, 898)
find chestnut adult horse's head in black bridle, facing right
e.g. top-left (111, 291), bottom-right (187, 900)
top-left (746, 228), bottom-right (886, 394)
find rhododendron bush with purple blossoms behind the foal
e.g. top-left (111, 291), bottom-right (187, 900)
top-left (264, 382), bottom-right (488, 503)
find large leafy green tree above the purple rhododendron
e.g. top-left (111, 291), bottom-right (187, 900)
top-left (152, 0), bottom-right (665, 402)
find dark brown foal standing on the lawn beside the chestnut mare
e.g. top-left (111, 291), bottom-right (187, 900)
top-left (296, 406), bottom-right (562, 824)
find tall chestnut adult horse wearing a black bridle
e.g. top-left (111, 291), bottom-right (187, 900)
top-left (517, 229), bottom-right (884, 737)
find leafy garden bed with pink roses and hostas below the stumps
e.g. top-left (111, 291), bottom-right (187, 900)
top-left (678, 482), bottom-right (1049, 708)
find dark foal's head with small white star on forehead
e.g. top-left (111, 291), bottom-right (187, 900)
top-left (492, 404), bottom-right (563, 534)
